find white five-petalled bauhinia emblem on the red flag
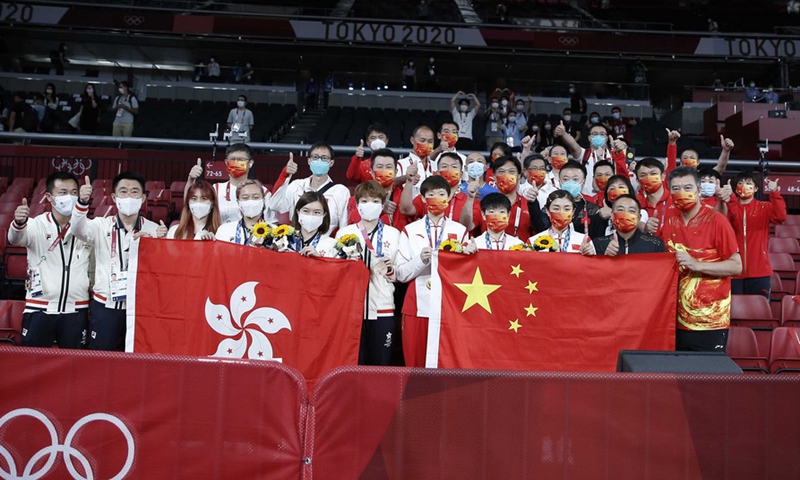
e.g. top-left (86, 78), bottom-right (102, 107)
top-left (206, 282), bottom-right (292, 362)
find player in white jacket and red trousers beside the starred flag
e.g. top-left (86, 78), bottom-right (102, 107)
top-left (395, 176), bottom-right (469, 367)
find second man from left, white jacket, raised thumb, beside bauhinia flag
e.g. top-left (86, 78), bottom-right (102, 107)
top-left (71, 172), bottom-right (167, 351)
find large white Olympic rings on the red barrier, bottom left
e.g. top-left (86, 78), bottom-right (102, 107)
top-left (0, 408), bottom-right (136, 480)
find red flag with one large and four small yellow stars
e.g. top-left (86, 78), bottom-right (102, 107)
top-left (426, 250), bottom-right (678, 372)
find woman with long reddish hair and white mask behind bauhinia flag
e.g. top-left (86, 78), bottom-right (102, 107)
top-left (167, 180), bottom-right (221, 240)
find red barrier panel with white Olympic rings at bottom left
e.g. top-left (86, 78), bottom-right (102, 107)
top-left (0, 347), bottom-right (308, 479)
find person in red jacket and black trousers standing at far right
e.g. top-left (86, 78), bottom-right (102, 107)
top-left (728, 172), bottom-right (786, 298)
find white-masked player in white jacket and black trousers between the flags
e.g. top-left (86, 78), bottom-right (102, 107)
top-left (336, 180), bottom-right (400, 365)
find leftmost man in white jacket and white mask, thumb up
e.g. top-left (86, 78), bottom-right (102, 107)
top-left (8, 172), bottom-right (92, 348)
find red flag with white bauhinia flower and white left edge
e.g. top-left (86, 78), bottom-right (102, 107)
top-left (125, 238), bottom-right (369, 384)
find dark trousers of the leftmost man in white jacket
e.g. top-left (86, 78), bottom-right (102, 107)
top-left (22, 308), bottom-right (89, 348)
